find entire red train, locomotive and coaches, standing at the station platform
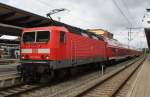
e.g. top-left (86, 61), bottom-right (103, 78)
top-left (19, 21), bottom-right (141, 81)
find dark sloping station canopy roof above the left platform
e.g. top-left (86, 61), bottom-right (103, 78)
top-left (0, 3), bottom-right (51, 28)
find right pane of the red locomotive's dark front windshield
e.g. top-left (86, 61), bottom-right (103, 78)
top-left (36, 31), bottom-right (50, 42)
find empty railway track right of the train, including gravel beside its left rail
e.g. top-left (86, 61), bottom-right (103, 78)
top-left (49, 55), bottom-right (145, 97)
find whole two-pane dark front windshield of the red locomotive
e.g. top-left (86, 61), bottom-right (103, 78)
top-left (23, 31), bottom-right (50, 43)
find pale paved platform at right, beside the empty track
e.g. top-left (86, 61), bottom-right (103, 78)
top-left (126, 55), bottom-right (150, 97)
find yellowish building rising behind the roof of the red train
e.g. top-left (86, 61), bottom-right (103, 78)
top-left (87, 29), bottom-right (113, 39)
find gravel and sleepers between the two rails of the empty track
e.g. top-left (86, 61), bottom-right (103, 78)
top-left (76, 58), bottom-right (144, 97)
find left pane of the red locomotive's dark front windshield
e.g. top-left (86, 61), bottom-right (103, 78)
top-left (23, 32), bottom-right (35, 43)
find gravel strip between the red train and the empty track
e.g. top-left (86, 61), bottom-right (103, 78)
top-left (20, 60), bottom-right (130, 97)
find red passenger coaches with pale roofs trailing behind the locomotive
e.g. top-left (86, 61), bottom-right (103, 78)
top-left (105, 38), bottom-right (140, 61)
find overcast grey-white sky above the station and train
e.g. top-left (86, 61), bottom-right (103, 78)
top-left (0, 0), bottom-right (150, 47)
